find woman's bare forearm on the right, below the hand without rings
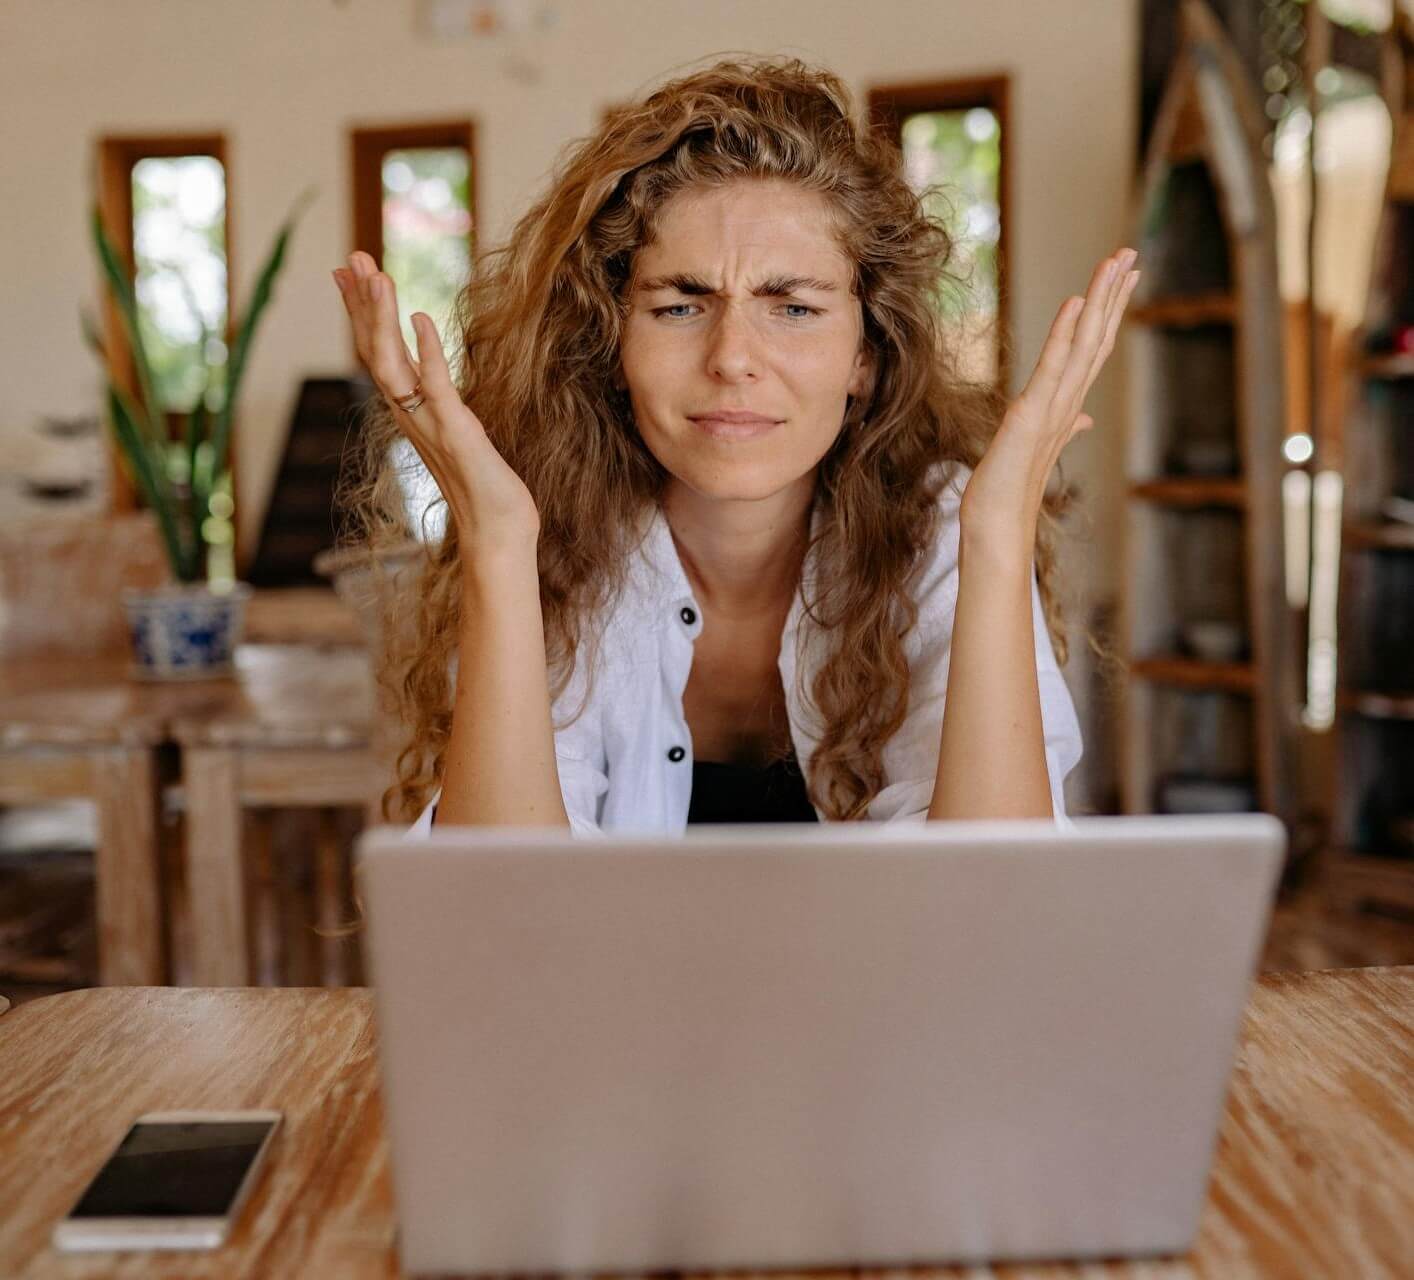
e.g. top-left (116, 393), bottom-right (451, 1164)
top-left (928, 525), bottom-right (1053, 819)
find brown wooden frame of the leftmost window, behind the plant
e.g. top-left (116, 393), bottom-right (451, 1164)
top-left (98, 133), bottom-right (231, 512)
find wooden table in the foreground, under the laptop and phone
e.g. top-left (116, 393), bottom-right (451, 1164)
top-left (0, 966), bottom-right (1414, 1280)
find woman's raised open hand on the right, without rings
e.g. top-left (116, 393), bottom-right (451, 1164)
top-left (962, 249), bottom-right (1140, 552)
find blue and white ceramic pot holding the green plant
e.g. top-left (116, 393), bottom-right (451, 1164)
top-left (123, 583), bottom-right (250, 680)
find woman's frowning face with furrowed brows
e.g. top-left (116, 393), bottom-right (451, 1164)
top-left (621, 181), bottom-right (868, 499)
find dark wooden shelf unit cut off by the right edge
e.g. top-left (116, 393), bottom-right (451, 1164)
top-left (1324, 10), bottom-right (1414, 912)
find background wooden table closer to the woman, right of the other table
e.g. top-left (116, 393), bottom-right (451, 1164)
top-left (171, 645), bottom-right (390, 987)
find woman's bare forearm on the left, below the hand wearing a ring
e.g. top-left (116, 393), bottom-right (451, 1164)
top-left (436, 550), bottom-right (570, 826)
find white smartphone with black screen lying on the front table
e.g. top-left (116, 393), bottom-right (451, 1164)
top-left (54, 1112), bottom-right (280, 1250)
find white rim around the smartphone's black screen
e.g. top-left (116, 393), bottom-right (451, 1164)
top-left (51, 1110), bottom-right (283, 1253)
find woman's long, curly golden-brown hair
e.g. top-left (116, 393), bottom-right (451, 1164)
top-left (342, 59), bottom-right (1072, 820)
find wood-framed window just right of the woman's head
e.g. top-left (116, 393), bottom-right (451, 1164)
top-left (870, 76), bottom-right (1010, 389)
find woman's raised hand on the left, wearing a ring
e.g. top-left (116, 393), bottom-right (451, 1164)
top-left (334, 250), bottom-right (540, 559)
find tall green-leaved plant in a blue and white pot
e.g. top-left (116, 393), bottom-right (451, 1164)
top-left (82, 191), bottom-right (312, 680)
